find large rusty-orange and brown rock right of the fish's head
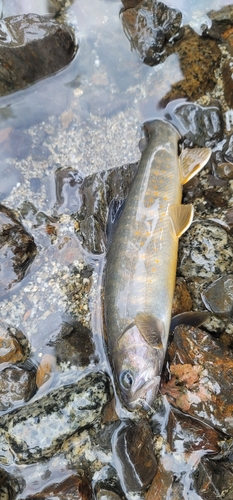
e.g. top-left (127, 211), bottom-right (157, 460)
top-left (162, 326), bottom-right (233, 435)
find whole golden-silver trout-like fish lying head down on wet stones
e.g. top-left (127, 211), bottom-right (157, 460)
top-left (104, 119), bottom-right (211, 410)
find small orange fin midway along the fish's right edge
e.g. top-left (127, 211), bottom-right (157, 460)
top-left (168, 205), bottom-right (194, 238)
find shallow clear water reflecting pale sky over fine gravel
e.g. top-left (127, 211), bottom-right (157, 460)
top-left (0, 0), bottom-right (230, 500)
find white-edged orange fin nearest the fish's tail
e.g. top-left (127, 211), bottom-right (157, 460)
top-left (179, 148), bottom-right (211, 184)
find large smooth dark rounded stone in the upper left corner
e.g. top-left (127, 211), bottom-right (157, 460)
top-left (0, 14), bottom-right (76, 95)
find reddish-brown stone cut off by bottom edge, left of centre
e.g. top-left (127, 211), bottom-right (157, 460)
top-left (26, 475), bottom-right (92, 500)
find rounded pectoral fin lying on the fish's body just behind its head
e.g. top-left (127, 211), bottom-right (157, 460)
top-left (134, 313), bottom-right (164, 349)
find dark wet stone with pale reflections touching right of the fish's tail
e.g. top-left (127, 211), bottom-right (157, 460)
top-left (175, 103), bottom-right (224, 147)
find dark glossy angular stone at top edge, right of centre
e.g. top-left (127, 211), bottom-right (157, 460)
top-left (122, 0), bottom-right (182, 66)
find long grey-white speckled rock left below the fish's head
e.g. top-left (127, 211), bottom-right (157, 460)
top-left (1, 372), bottom-right (110, 463)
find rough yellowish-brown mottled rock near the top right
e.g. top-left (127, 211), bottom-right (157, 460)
top-left (164, 27), bottom-right (221, 102)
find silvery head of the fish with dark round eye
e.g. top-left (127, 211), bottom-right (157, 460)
top-left (114, 321), bottom-right (164, 410)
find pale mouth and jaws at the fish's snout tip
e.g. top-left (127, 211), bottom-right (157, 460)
top-left (126, 375), bottom-right (161, 410)
